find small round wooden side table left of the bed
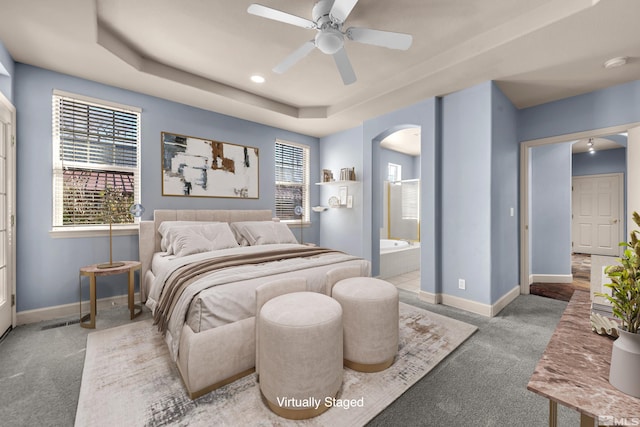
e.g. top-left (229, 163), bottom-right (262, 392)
top-left (78, 261), bottom-right (142, 329)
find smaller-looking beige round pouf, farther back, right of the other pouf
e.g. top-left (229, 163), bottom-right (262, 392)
top-left (332, 277), bottom-right (399, 372)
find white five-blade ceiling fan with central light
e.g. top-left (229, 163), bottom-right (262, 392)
top-left (247, 0), bottom-right (413, 85)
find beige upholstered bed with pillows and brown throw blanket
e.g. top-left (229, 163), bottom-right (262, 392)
top-left (139, 210), bottom-right (370, 398)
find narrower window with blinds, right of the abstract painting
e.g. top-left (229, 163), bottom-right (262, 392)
top-left (275, 140), bottom-right (310, 222)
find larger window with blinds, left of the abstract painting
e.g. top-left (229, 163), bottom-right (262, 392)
top-left (52, 91), bottom-right (140, 228)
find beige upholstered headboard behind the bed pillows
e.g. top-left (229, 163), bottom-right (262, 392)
top-left (138, 209), bottom-right (273, 300)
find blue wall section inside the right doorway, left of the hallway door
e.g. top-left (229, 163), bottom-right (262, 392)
top-left (529, 142), bottom-right (571, 275)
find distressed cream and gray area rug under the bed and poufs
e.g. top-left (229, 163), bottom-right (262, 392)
top-left (75, 303), bottom-right (477, 427)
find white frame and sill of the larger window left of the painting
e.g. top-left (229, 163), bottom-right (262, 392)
top-left (50, 89), bottom-right (142, 238)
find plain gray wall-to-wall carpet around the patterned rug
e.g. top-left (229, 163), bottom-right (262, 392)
top-left (0, 291), bottom-right (579, 427)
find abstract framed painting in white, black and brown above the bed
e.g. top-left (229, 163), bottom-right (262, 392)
top-left (161, 132), bottom-right (259, 199)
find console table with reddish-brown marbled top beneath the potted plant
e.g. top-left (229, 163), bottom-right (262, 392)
top-left (527, 291), bottom-right (640, 427)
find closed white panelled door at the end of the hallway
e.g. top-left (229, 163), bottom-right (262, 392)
top-left (571, 174), bottom-right (623, 256)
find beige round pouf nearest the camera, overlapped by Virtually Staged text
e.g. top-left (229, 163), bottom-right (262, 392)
top-left (258, 292), bottom-right (343, 420)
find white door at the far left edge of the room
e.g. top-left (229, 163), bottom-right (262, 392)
top-left (0, 93), bottom-right (15, 336)
